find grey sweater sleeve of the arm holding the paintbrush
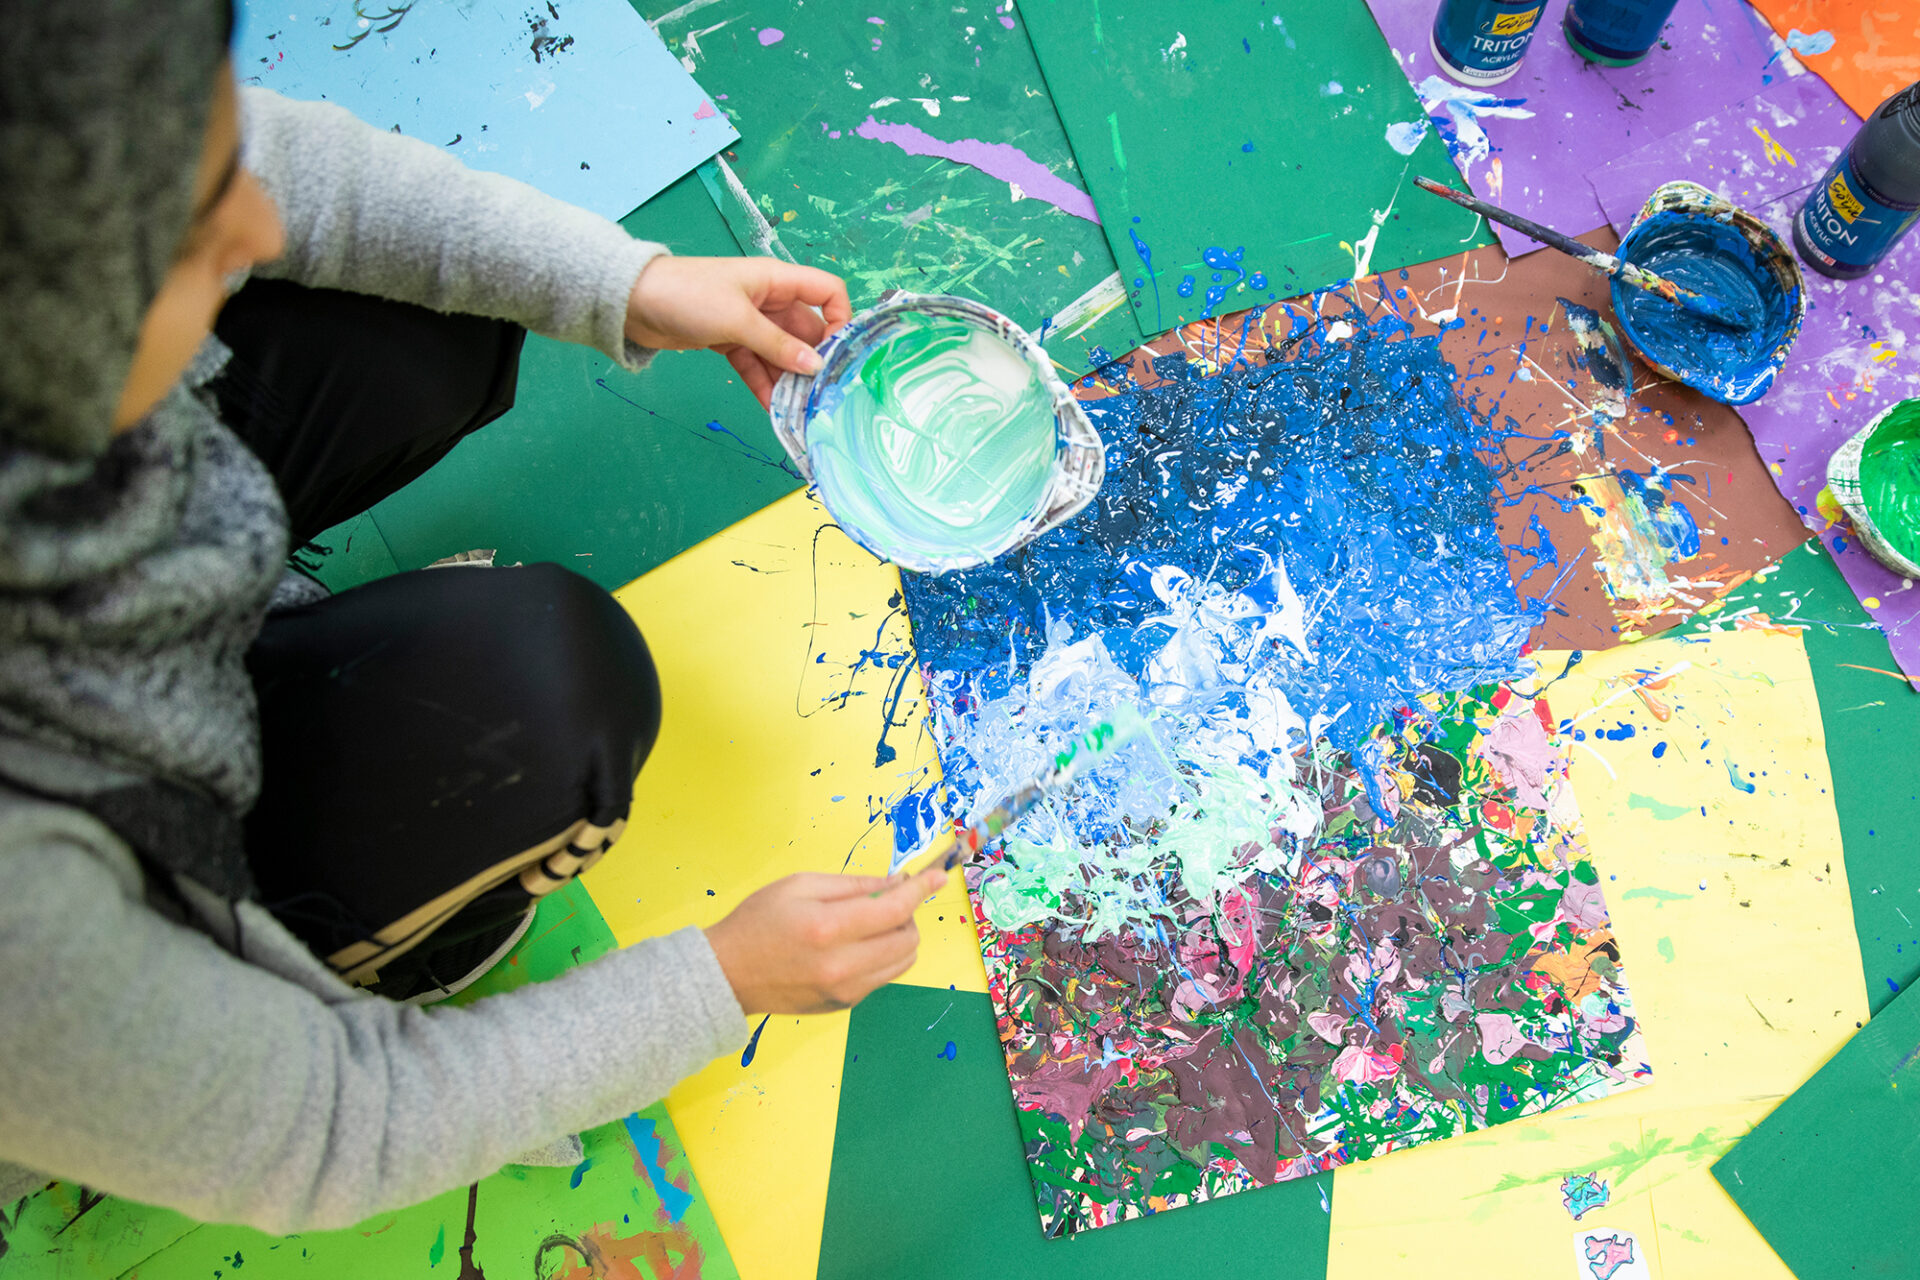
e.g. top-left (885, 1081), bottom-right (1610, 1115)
top-left (0, 804), bottom-right (747, 1232)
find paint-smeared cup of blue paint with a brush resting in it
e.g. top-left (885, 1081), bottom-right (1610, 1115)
top-left (1613, 182), bottom-right (1807, 405)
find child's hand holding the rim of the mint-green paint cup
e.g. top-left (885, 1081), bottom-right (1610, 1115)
top-left (626, 257), bottom-right (852, 405)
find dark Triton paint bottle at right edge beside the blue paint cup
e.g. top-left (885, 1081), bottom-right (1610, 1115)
top-left (1793, 84), bottom-right (1920, 280)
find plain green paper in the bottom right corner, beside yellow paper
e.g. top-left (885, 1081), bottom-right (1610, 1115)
top-left (1713, 992), bottom-right (1920, 1280)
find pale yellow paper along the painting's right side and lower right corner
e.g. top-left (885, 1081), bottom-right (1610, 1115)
top-left (1327, 631), bottom-right (1866, 1280)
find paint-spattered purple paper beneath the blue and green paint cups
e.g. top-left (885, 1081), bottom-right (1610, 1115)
top-left (1590, 75), bottom-right (1920, 677)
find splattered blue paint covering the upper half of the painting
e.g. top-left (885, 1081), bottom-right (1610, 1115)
top-left (904, 301), bottom-right (1546, 808)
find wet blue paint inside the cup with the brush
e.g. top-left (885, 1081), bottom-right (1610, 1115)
top-left (1613, 211), bottom-right (1795, 403)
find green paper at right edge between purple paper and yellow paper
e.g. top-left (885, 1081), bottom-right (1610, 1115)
top-left (1690, 541), bottom-right (1920, 1011)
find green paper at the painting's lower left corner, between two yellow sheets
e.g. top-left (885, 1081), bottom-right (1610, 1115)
top-left (820, 983), bottom-right (1332, 1280)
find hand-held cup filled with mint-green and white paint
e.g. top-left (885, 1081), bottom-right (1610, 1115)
top-left (772, 290), bottom-right (1106, 574)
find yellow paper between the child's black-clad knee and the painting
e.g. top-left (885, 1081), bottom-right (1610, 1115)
top-left (586, 493), bottom-right (987, 1280)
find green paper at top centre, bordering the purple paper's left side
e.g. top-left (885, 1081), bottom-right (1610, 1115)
top-left (1013, 0), bottom-right (1494, 334)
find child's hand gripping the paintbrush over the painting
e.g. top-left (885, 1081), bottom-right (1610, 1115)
top-left (707, 869), bottom-right (947, 1013)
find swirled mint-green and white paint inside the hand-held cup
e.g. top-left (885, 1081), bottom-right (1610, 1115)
top-left (808, 315), bottom-right (1056, 560)
